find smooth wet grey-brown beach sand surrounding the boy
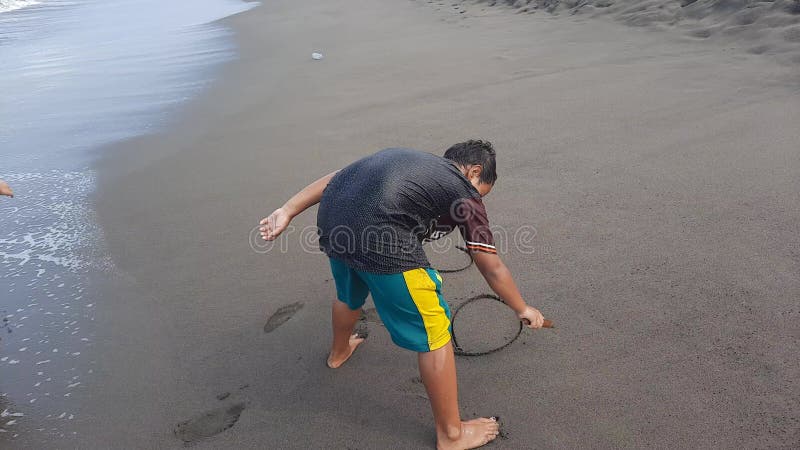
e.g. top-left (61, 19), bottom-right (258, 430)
top-left (83, 0), bottom-right (800, 449)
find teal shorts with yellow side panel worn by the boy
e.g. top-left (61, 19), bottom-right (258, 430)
top-left (330, 258), bottom-right (451, 352)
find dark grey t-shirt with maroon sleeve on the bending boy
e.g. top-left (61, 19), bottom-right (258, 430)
top-left (317, 148), bottom-right (496, 273)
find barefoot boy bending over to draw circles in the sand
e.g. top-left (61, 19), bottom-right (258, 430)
top-left (260, 141), bottom-right (544, 449)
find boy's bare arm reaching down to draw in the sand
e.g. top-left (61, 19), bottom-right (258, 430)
top-left (472, 252), bottom-right (544, 328)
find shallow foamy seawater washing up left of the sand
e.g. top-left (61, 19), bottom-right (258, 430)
top-left (0, 0), bottom-right (256, 448)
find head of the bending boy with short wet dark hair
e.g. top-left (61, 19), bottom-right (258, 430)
top-left (444, 140), bottom-right (497, 197)
